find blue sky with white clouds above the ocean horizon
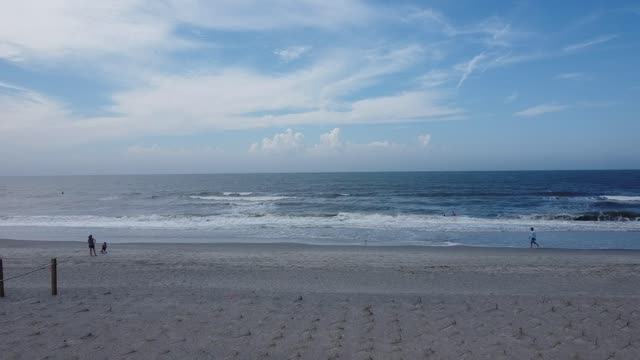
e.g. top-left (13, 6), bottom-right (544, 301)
top-left (0, 0), bottom-right (640, 175)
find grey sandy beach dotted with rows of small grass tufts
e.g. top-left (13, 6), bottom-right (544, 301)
top-left (0, 240), bottom-right (640, 359)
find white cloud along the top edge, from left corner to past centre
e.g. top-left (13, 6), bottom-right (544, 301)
top-left (0, 0), bottom-right (376, 61)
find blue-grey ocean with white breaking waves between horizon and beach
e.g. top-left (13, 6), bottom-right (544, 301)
top-left (0, 170), bottom-right (640, 249)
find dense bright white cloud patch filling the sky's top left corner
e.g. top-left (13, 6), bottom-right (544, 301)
top-left (0, 0), bottom-right (179, 60)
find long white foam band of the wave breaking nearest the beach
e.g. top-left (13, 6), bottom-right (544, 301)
top-left (0, 213), bottom-right (640, 233)
